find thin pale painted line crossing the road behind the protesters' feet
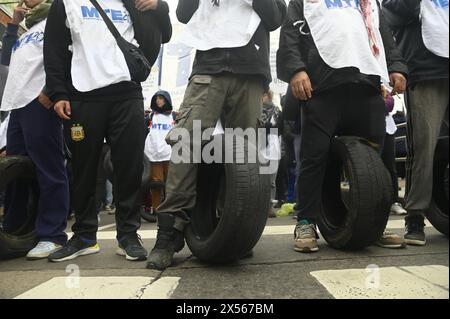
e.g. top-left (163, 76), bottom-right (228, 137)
top-left (76, 220), bottom-right (432, 240)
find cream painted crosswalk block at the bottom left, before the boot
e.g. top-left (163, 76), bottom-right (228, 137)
top-left (15, 276), bottom-right (180, 299)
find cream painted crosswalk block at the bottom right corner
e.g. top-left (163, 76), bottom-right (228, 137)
top-left (310, 265), bottom-right (449, 299)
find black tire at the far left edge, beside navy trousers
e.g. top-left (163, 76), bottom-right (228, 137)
top-left (0, 156), bottom-right (39, 260)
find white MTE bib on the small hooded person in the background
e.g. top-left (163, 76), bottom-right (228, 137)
top-left (145, 113), bottom-right (174, 162)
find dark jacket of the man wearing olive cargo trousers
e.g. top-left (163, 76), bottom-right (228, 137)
top-left (177, 0), bottom-right (286, 84)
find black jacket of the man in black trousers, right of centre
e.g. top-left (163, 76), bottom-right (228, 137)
top-left (277, 0), bottom-right (408, 93)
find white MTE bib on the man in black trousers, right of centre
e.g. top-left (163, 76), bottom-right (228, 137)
top-left (304, 0), bottom-right (389, 83)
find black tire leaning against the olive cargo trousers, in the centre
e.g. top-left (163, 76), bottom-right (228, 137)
top-left (185, 138), bottom-right (270, 264)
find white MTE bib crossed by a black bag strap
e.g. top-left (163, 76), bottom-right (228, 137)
top-left (63, 0), bottom-right (137, 92)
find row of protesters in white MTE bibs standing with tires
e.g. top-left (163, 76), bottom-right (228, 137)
top-left (1, 0), bottom-right (449, 270)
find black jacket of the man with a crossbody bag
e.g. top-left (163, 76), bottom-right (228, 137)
top-left (44, 0), bottom-right (172, 102)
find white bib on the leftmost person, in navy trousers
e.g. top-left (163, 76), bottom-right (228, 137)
top-left (0, 20), bottom-right (47, 111)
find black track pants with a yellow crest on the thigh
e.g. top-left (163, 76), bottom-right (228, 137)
top-left (65, 100), bottom-right (145, 240)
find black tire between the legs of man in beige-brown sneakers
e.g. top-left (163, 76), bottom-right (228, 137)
top-left (318, 137), bottom-right (393, 250)
